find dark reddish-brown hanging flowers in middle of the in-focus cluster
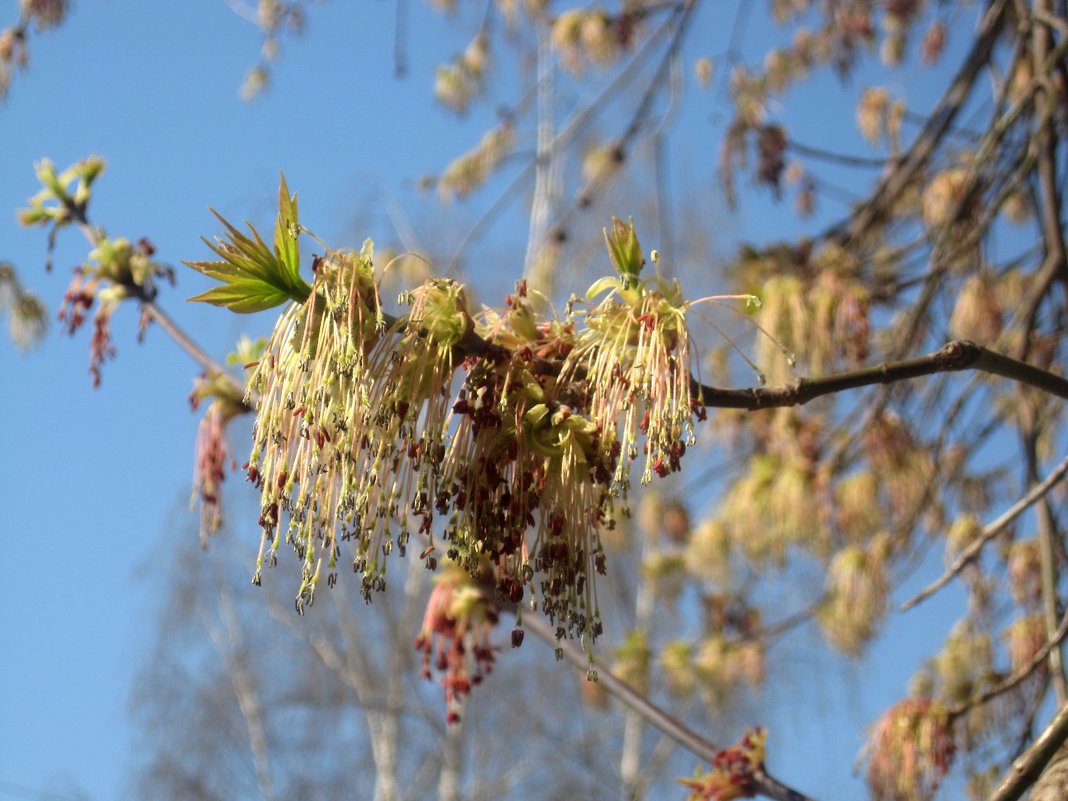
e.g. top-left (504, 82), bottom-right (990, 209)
top-left (444, 285), bottom-right (612, 645)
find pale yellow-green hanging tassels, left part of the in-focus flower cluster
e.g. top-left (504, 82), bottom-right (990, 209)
top-left (247, 241), bottom-right (473, 610)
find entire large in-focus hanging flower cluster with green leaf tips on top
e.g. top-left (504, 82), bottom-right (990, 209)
top-left (193, 187), bottom-right (702, 666)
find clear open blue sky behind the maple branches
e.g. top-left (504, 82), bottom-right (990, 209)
top-left (0, 0), bottom-right (978, 801)
